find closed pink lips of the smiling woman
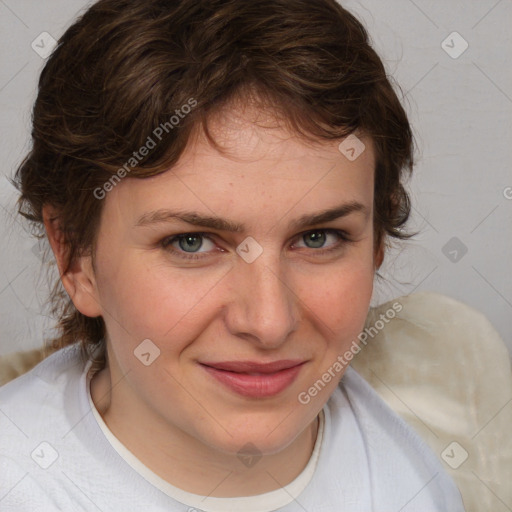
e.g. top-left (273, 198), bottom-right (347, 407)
top-left (200, 359), bottom-right (305, 398)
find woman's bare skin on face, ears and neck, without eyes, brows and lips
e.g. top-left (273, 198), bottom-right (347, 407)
top-left (44, 102), bottom-right (383, 497)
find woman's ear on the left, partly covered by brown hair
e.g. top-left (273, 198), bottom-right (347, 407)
top-left (43, 205), bottom-right (102, 317)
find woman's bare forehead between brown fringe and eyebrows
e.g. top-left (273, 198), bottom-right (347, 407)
top-left (105, 105), bottom-right (375, 220)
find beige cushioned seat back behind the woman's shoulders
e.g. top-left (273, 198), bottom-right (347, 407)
top-left (0, 292), bottom-right (512, 512)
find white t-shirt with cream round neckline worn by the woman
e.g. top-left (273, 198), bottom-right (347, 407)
top-left (0, 345), bottom-right (464, 512)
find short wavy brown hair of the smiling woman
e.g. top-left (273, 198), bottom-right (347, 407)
top-left (15, 0), bottom-right (413, 369)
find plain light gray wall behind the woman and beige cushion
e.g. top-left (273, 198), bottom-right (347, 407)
top-left (0, 0), bottom-right (512, 354)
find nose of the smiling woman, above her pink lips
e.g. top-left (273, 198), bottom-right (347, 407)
top-left (225, 256), bottom-right (299, 349)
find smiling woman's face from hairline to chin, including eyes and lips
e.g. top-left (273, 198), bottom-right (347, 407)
top-left (79, 104), bottom-right (376, 453)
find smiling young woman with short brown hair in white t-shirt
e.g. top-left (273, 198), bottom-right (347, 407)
top-left (0, 0), bottom-right (463, 512)
